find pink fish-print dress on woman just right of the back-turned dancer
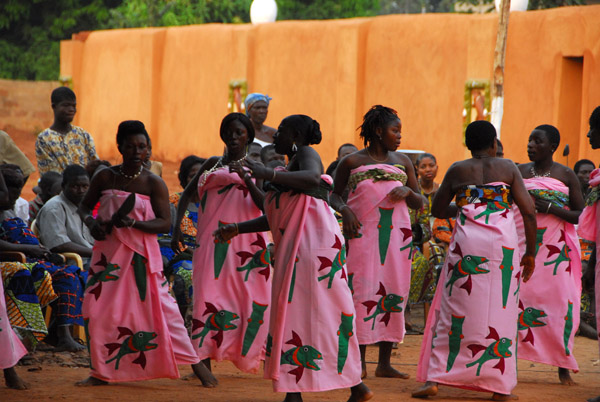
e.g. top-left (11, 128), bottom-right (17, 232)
top-left (515, 177), bottom-right (581, 371)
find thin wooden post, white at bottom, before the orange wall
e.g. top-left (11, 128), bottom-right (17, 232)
top-left (491, 0), bottom-right (510, 138)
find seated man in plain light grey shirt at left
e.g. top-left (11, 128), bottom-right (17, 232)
top-left (36, 165), bottom-right (94, 267)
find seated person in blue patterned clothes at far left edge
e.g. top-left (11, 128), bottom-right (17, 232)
top-left (0, 165), bottom-right (87, 351)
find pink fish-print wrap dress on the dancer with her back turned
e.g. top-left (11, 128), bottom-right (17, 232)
top-left (417, 183), bottom-right (521, 394)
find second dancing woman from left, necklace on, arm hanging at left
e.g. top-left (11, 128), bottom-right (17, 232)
top-left (172, 113), bottom-right (271, 384)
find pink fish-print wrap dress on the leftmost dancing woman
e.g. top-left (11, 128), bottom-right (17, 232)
top-left (83, 190), bottom-right (199, 382)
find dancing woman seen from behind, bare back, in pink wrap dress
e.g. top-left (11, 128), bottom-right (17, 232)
top-left (412, 121), bottom-right (536, 400)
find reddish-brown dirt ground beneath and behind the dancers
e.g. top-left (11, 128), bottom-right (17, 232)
top-left (0, 130), bottom-right (600, 402)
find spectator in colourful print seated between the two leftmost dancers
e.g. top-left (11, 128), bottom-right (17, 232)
top-left (159, 155), bottom-right (206, 319)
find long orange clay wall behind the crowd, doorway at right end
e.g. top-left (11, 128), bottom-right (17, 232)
top-left (61, 6), bottom-right (600, 173)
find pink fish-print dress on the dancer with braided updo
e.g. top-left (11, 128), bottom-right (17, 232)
top-left (347, 164), bottom-right (413, 345)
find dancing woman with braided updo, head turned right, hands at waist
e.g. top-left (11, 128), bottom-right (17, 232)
top-left (331, 105), bottom-right (423, 379)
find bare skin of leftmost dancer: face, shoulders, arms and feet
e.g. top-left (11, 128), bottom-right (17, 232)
top-left (76, 133), bottom-right (216, 386)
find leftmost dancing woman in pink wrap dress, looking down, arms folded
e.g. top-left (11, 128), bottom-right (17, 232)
top-left (78, 120), bottom-right (210, 385)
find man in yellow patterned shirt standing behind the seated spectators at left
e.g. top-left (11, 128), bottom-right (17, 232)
top-left (35, 87), bottom-right (98, 175)
